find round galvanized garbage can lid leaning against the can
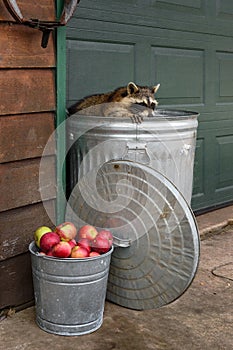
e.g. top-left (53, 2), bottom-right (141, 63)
top-left (66, 160), bottom-right (199, 310)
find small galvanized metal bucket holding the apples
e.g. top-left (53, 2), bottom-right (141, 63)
top-left (29, 242), bottom-right (113, 336)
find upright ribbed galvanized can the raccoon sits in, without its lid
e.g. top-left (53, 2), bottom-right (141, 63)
top-left (68, 109), bottom-right (198, 204)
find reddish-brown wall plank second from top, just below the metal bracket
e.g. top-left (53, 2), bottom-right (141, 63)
top-left (0, 23), bottom-right (55, 68)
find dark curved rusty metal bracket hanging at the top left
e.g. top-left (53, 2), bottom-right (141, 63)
top-left (3, 0), bottom-right (80, 48)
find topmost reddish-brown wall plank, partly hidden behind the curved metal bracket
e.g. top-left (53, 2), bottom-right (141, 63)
top-left (0, 0), bottom-right (55, 21)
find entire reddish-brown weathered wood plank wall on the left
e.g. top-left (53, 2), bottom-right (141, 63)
top-left (0, 0), bottom-right (56, 309)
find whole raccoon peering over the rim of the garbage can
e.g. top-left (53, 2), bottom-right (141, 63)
top-left (68, 82), bottom-right (160, 123)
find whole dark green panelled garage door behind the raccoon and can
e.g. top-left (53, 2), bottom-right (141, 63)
top-left (67, 0), bottom-right (233, 210)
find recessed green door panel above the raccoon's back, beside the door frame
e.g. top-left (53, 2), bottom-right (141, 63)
top-left (68, 40), bottom-right (135, 102)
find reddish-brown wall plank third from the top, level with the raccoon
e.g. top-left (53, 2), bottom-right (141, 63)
top-left (0, 69), bottom-right (55, 115)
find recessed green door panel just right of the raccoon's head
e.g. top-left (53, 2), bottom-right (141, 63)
top-left (151, 47), bottom-right (204, 105)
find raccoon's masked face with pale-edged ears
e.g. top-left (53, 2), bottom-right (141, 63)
top-left (126, 83), bottom-right (160, 109)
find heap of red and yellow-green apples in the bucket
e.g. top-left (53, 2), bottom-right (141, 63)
top-left (34, 222), bottom-right (113, 258)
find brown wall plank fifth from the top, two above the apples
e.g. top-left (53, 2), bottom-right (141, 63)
top-left (0, 156), bottom-right (56, 211)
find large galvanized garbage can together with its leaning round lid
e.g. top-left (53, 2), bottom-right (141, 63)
top-left (66, 110), bottom-right (200, 310)
